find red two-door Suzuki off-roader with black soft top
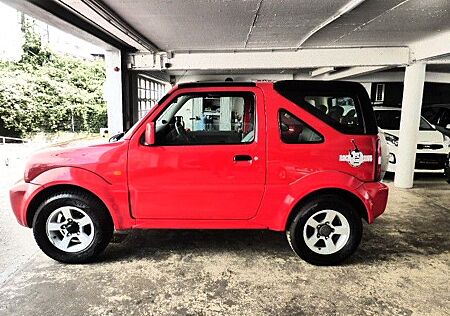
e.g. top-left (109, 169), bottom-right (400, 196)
top-left (10, 81), bottom-right (388, 265)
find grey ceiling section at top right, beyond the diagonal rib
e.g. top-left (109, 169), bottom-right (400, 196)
top-left (305, 0), bottom-right (450, 46)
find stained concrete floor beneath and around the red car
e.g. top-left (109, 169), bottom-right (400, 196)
top-left (0, 170), bottom-right (450, 315)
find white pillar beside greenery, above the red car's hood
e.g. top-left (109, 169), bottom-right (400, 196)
top-left (105, 50), bottom-right (123, 136)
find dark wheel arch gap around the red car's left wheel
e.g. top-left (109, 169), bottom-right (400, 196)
top-left (27, 184), bottom-right (114, 228)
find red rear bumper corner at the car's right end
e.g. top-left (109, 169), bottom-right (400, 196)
top-left (358, 182), bottom-right (389, 224)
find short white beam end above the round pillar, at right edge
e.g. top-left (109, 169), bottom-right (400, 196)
top-left (409, 30), bottom-right (450, 61)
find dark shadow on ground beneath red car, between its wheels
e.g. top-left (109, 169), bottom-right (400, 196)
top-left (100, 230), bottom-right (293, 262)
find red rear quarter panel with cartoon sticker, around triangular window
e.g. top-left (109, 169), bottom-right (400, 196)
top-left (251, 85), bottom-right (377, 230)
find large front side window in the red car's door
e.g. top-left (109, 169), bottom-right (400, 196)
top-left (155, 93), bottom-right (255, 145)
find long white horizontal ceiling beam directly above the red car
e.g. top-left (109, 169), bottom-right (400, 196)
top-left (129, 47), bottom-right (410, 71)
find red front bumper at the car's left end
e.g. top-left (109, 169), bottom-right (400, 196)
top-left (9, 180), bottom-right (41, 227)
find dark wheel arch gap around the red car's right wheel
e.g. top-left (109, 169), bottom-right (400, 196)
top-left (284, 188), bottom-right (368, 230)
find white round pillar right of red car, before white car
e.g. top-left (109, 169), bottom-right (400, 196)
top-left (394, 63), bottom-right (426, 189)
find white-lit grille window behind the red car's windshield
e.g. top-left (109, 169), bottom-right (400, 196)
top-left (137, 76), bottom-right (166, 119)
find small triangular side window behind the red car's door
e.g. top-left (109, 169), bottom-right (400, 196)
top-left (279, 110), bottom-right (323, 144)
